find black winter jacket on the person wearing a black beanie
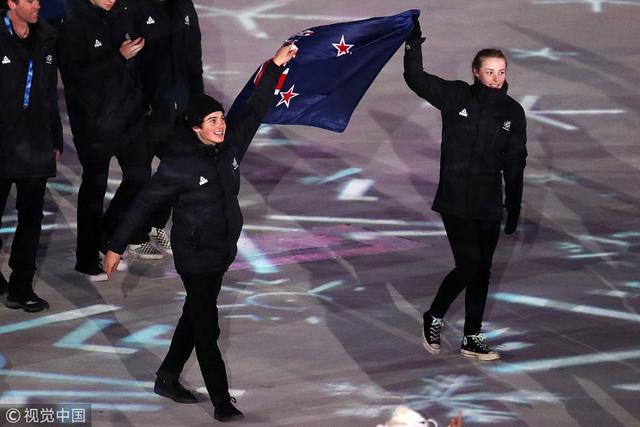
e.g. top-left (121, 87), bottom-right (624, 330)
top-left (109, 61), bottom-right (283, 274)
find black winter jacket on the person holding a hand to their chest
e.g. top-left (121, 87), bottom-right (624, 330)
top-left (58, 0), bottom-right (144, 150)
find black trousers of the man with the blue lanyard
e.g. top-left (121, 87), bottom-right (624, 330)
top-left (0, 178), bottom-right (47, 296)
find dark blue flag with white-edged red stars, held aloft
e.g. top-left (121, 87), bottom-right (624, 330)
top-left (227, 10), bottom-right (420, 132)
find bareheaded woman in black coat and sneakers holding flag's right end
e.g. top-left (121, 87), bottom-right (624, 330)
top-left (404, 17), bottom-right (527, 360)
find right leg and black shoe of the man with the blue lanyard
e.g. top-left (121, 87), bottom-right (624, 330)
top-left (7, 178), bottom-right (49, 312)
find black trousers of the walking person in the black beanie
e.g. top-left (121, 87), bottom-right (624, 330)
top-left (157, 273), bottom-right (229, 405)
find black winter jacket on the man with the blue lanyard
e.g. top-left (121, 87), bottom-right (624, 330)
top-left (0, 10), bottom-right (62, 179)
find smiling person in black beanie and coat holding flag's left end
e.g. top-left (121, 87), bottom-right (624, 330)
top-left (105, 41), bottom-right (297, 421)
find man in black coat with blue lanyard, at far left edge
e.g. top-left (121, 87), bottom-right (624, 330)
top-left (0, 0), bottom-right (63, 312)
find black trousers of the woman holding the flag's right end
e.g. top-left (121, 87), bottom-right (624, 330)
top-left (429, 215), bottom-right (500, 335)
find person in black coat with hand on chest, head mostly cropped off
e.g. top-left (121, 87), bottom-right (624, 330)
top-left (58, 0), bottom-right (162, 281)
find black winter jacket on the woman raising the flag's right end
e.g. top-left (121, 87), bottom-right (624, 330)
top-left (404, 40), bottom-right (527, 220)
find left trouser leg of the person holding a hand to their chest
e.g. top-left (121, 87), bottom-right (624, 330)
top-left (75, 151), bottom-right (111, 275)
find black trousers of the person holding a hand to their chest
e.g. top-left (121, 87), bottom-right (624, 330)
top-left (74, 132), bottom-right (151, 272)
